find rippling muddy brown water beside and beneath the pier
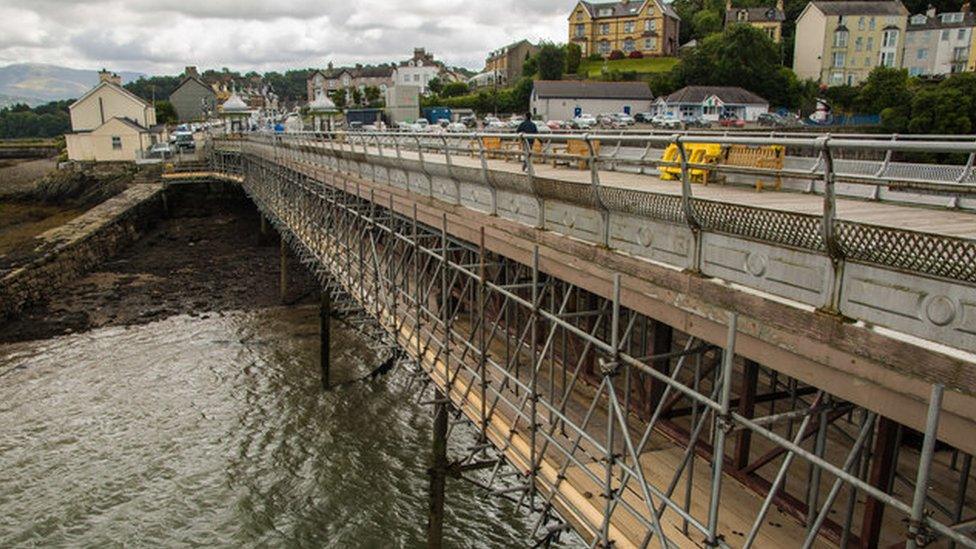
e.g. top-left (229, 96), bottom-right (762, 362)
top-left (0, 201), bottom-right (576, 547)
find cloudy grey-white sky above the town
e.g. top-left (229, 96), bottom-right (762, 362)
top-left (0, 0), bottom-right (575, 74)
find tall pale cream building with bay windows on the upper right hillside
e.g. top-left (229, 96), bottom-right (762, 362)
top-left (793, 1), bottom-right (908, 86)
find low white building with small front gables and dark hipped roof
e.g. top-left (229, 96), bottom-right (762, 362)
top-left (654, 86), bottom-right (769, 122)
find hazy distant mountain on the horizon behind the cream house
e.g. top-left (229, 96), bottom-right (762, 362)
top-left (0, 63), bottom-right (143, 104)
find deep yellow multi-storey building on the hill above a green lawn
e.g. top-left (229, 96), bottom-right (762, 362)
top-left (569, 0), bottom-right (681, 57)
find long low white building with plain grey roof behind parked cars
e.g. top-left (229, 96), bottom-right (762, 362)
top-left (529, 80), bottom-right (654, 120)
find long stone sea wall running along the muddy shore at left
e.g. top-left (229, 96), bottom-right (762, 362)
top-left (0, 183), bottom-right (165, 320)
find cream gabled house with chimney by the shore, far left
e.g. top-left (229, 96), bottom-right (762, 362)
top-left (65, 70), bottom-right (163, 162)
